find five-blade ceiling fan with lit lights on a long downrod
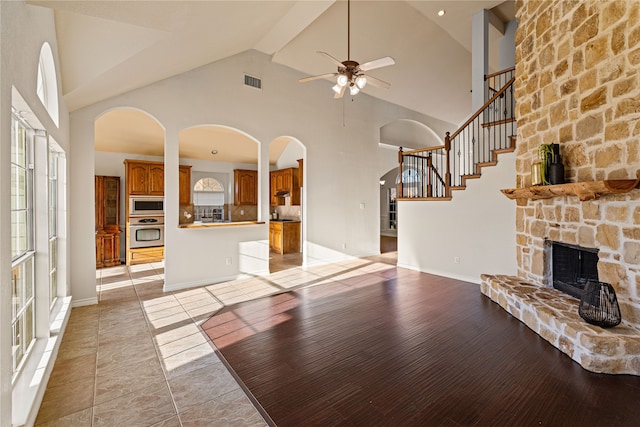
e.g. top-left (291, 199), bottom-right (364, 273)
top-left (299, 0), bottom-right (396, 98)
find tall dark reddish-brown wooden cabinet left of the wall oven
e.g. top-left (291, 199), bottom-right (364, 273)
top-left (95, 176), bottom-right (121, 268)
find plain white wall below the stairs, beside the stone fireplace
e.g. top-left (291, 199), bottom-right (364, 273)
top-left (398, 153), bottom-right (516, 283)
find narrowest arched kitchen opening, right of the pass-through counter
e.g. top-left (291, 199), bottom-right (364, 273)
top-left (269, 136), bottom-right (308, 273)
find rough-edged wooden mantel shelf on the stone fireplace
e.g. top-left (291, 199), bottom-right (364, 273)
top-left (500, 179), bottom-right (640, 202)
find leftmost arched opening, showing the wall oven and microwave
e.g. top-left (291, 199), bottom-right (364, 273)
top-left (94, 107), bottom-right (165, 268)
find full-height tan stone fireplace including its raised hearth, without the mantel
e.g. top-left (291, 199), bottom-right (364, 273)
top-left (482, 0), bottom-right (640, 375)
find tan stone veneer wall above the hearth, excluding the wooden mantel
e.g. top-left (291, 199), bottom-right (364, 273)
top-left (515, 0), bottom-right (640, 328)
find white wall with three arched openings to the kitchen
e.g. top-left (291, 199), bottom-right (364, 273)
top-left (71, 51), bottom-right (444, 293)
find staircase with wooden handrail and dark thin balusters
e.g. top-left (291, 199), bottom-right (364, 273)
top-left (398, 68), bottom-right (516, 200)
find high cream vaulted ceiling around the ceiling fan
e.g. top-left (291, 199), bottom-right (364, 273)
top-left (29, 0), bottom-right (513, 160)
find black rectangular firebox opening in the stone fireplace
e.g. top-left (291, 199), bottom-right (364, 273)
top-left (551, 242), bottom-right (598, 299)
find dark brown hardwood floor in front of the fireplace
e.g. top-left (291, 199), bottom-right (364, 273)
top-left (202, 260), bottom-right (640, 427)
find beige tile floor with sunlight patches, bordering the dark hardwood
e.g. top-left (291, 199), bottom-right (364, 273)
top-left (36, 252), bottom-right (396, 427)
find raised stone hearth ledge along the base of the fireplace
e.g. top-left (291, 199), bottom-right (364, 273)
top-left (480, 274), bottom-right (640, 375)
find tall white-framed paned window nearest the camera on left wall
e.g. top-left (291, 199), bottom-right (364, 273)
top-left (11, 113), bottom-right (35, 374)
